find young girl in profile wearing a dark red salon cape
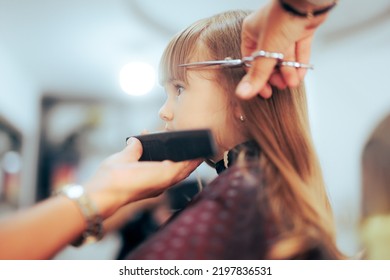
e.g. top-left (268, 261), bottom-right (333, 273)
top-left (129, 11), bottom-right (341, 259)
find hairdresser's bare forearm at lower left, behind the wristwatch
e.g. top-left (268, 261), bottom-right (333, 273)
top-left (0, 196), bottom-right (86, 259)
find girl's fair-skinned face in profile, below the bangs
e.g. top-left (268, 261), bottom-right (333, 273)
top-left (159, 71), bottom-right (241, 160)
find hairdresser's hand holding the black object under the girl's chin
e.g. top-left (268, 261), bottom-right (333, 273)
top-left (85, 138), bottom-right (202, 218)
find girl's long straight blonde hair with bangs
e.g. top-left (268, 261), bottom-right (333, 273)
top-left (160, 11), bottom-right (342, 259)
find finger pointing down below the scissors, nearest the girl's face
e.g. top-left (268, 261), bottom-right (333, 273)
top-left (236, 58), bottom-right (277, 99)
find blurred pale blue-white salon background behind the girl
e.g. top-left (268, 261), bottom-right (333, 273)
top-left (0, 0), bottom-right (390, 258)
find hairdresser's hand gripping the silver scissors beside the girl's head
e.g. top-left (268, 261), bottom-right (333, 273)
top-left (237, 0), bottom-right (326, 99)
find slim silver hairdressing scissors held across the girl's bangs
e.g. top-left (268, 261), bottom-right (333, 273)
top-left (179, 50), bottom-right (314, 70)
